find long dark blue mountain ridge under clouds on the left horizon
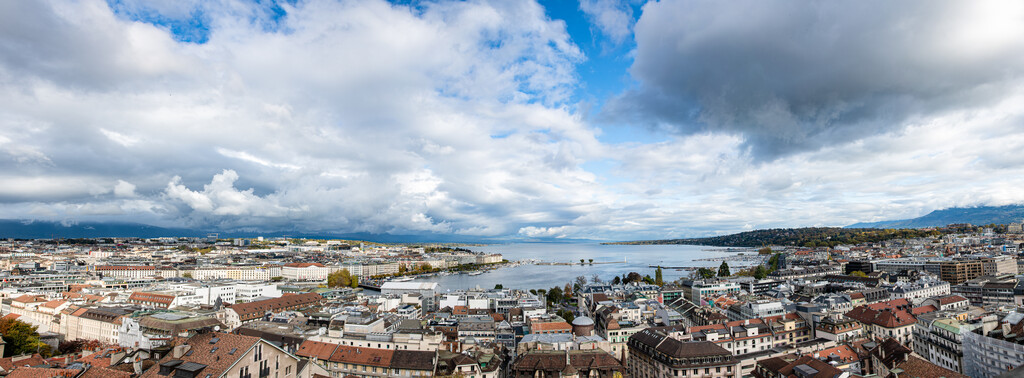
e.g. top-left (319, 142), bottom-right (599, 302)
top-left (0, 219), bottom-right (588, 244)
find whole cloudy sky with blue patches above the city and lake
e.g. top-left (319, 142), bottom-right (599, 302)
top-left (0, 0), bottom-right (1024, 240)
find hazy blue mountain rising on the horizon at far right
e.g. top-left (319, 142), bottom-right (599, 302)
top-left (846, 205), bottom-right (1024, 228)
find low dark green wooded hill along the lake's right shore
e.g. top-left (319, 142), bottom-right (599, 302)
top-left (605, 227), bottom-right (950, 247)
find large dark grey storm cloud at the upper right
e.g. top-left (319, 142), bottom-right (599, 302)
top-left (605, 1), bottom-right (1024, 159)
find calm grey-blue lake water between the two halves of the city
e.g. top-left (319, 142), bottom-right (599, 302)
top-left (401, 243), bottom-right (757, 292)
